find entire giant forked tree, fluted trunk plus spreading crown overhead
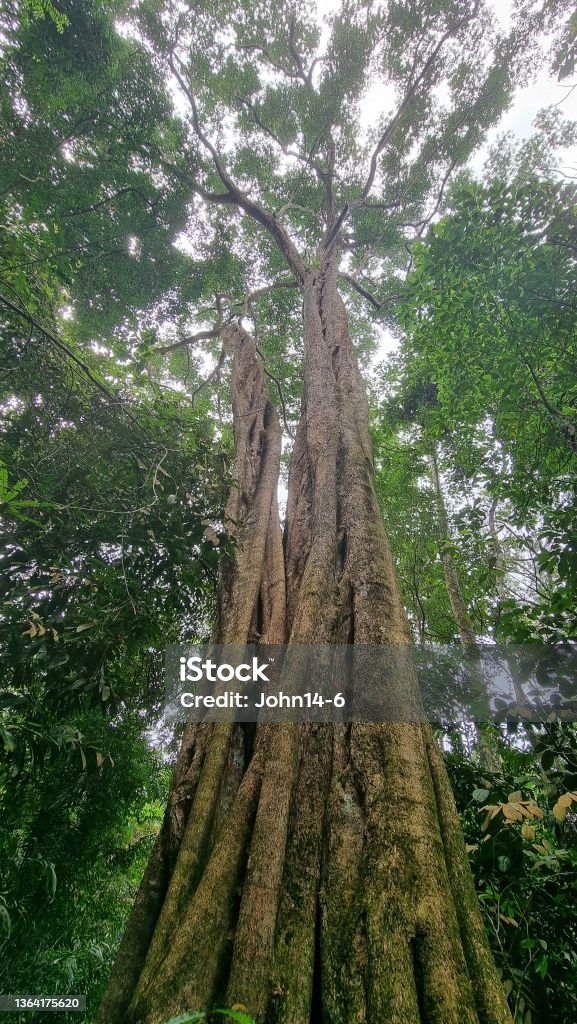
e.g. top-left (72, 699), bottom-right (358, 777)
top-left (5, 0), bottom-right (563, 1024)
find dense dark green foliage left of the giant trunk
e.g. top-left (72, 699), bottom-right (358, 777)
top-left (0, 5), bottom-right (229, 1007)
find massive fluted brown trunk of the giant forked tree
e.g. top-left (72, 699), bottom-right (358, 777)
top-left (97, 256), bottom-right (511, 1024)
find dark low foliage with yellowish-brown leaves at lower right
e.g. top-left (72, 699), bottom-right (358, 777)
top-left (447, 736), bottom-right (577, 1024)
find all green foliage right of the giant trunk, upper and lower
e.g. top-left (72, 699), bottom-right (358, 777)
top-left (374, 157), bottom-right (577, 1024)
